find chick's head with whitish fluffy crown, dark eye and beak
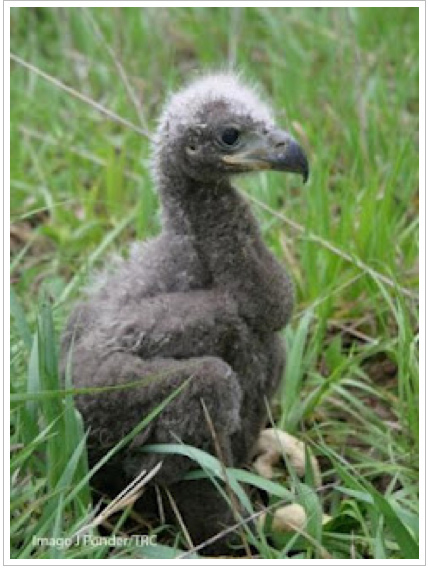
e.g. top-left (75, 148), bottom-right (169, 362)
top-left (154, 74), bottom-right (309, 182)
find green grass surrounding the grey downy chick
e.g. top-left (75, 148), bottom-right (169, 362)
top-left (10, 8), bottom-right (419, 559)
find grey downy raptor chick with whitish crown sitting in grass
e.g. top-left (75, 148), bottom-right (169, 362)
top-left (60, 72), bottom-right (309, 554)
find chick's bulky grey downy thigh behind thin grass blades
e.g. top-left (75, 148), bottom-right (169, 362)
top-left (73, 348), bottom-right (242, 484)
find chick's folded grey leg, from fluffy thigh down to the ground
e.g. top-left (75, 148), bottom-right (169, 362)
top-left (73, 348), bottom-right (247, 554)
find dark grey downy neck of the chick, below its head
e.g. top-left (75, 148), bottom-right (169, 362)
top-left (158, 169), bottom-right (293, 331)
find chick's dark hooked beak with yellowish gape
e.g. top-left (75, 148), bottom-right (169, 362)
top-left (223, 129), bottom-right (309, 182)
